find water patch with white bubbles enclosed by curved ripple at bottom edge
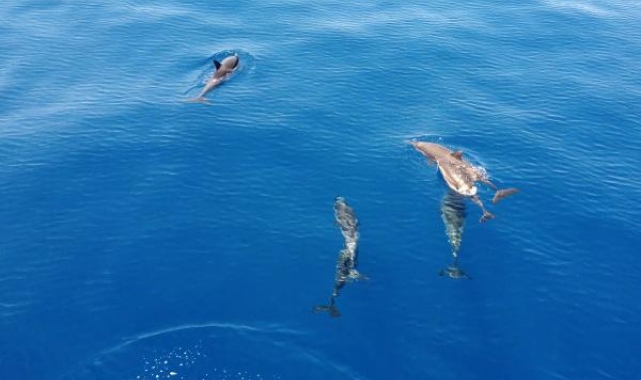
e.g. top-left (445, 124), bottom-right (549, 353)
top-left (62, 322), bottom-right (362, 380)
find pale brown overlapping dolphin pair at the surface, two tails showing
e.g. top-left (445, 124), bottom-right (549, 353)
top-left (411, 141), bottom-right (519, 222)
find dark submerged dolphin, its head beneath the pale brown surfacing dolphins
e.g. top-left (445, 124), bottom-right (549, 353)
top-left (439, 189), bottom-right (470, 279)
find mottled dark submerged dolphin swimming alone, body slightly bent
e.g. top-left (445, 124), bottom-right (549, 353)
top-left (314, 197), bottom-right (366, 318)
